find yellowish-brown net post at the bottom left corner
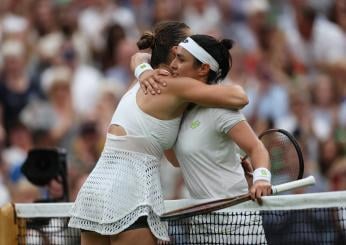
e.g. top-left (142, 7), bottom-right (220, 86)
top-left (0, 203), bottom-right (18, 245)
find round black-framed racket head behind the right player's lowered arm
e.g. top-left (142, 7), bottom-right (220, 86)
top-left (243, 129), bottom-right (304, 185)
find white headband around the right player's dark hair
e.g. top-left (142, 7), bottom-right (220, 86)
top-left (179, 37), bottom-right (219, 73)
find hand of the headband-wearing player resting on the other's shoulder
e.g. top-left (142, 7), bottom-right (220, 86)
top-left (139, 69), bottom-right (170, 95)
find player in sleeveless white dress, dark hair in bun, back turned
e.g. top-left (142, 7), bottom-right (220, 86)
top-left (69, 22), bottom-right (247, 245)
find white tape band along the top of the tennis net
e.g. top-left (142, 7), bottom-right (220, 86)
top-left (15, 191), bottom-right (346, 218)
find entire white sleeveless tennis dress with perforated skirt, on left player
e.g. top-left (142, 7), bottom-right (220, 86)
top-left (69, 83), bottom-right (181, 240)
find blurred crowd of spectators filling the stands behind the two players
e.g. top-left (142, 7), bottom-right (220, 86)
top-left (0, 0), bottom-right (346, 206)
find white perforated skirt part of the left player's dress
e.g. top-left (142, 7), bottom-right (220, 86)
top-left (69, 136), bottom-right (169, 240)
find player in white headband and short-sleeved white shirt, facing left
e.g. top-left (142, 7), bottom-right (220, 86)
top-left (135, 35), bottom-right (271, 244)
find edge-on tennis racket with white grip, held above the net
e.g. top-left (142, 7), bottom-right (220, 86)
top-left (160, 176), bottom-right (315, 221)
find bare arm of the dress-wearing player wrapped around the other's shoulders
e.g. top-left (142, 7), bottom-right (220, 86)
top-left (165, 77), bottom-right (249, 110)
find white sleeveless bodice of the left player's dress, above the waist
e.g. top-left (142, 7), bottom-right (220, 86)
top-left (111, 83), bottom-right (181, 158)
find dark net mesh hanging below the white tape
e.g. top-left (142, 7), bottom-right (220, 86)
top-left (17, 207), bottom-right (346, 245)
